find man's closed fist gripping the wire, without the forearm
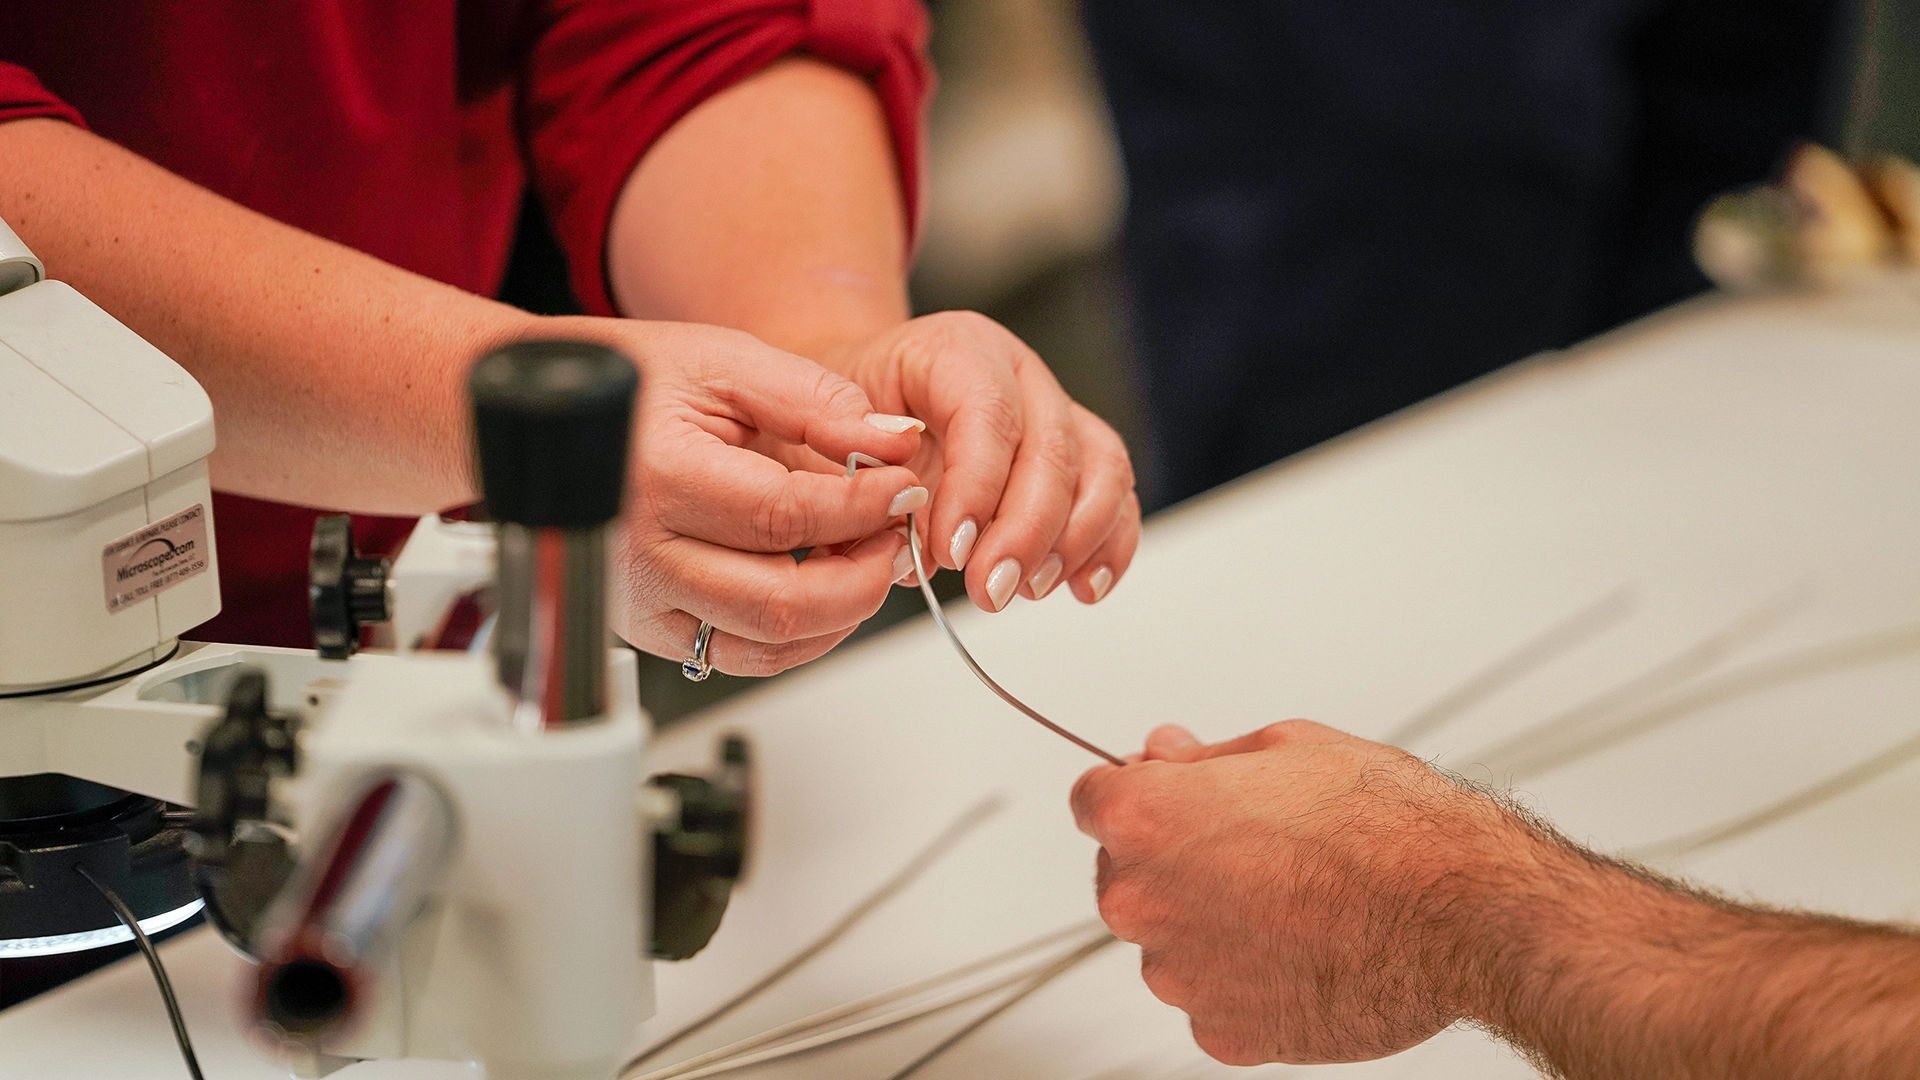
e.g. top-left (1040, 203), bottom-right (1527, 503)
top-left (1073, 721), bottom-right (1526, 1065)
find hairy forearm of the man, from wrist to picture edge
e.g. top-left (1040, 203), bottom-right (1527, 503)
top-left (1463, 818), bottom-right (1920, 1080)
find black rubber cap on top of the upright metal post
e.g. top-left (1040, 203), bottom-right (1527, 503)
top-left (467, 342), bottom-right (639, 528)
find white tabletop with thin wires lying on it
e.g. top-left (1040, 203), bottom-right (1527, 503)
top-left (0, 282), bottom-right (1920, 1080)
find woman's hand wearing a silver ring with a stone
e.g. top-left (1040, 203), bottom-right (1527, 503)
top-left (543, 319), bottom-right (927, 675)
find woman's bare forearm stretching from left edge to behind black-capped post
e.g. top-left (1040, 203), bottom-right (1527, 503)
top-left (0, 119), bottom-right (536, 513)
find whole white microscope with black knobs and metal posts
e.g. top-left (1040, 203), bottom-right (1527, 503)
top-left (0, 214), bottom-right (747, 1080)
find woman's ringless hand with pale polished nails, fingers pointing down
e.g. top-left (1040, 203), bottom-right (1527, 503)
top-left (816, 311), bottom-right (1140, 611)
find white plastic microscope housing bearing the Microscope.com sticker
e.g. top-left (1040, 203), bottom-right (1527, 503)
top-left (0, 272), bottom-right (221, 692)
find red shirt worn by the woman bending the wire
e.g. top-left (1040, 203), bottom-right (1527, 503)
top-left (0, 0), bottom-right (929, 648)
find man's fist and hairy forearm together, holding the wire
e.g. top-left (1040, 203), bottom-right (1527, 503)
top-left (1073, 721), bottom-right (1920, 1080)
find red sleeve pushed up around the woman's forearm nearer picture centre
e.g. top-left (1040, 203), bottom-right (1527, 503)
top-left (520, 0), bottom-right (931, 315)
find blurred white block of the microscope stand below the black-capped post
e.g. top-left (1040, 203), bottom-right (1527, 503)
top-left (288, 650), bottom-right (653, 1080)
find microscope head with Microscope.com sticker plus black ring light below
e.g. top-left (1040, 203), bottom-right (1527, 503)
top-left (0, 223), bottom-right (221, 959)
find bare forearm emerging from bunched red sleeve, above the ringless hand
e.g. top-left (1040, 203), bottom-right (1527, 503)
top-left (607, 58), bottom-right (908, 361)
